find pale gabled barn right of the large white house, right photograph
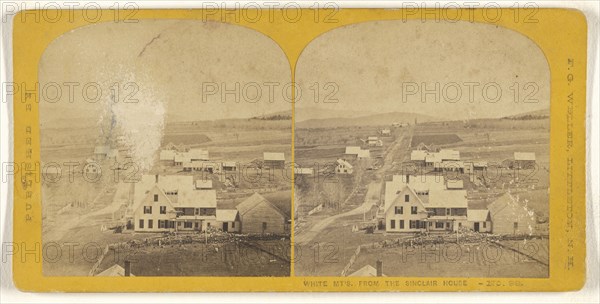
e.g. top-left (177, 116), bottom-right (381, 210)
top-left (488, 192), bottom-right (536, 234)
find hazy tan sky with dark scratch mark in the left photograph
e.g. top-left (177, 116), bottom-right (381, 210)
top-left (39, 20), bottom-right (291, 128)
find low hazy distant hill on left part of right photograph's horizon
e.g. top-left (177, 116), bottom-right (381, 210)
top-left (296, 112), bottom-right (445, 128)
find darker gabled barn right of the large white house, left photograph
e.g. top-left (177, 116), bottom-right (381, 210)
top-left (236, 193), bottom-right (286, 234)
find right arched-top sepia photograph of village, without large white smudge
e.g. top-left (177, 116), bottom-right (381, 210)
top-left (293, 20), bottom-right (551, 280)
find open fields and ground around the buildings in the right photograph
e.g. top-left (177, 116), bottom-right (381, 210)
top-left (295, 115), bottom-right (550, 277)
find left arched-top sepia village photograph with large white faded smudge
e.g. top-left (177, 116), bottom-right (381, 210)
top-left (38, 20), bottom-right (293, 277)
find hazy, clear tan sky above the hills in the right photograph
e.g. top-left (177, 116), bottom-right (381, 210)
top-left (296, 20), bottom-right (550, 120)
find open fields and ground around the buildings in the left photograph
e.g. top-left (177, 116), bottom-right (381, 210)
top-left (41, 119), bottom-right (291, 276)
